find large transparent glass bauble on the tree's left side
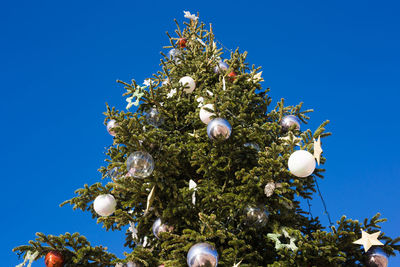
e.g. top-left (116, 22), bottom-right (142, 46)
top-left (126, 151), bottom-right (154, 178)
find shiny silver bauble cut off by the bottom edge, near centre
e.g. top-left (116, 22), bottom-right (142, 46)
top-left (187, 243), bottom-right (218, 267)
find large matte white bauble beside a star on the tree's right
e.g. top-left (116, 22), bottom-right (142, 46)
top-left (288, 150), bottom-right (315, 177)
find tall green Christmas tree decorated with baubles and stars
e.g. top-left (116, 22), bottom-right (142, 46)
top-left (14, 12), bottom-right (400, 267)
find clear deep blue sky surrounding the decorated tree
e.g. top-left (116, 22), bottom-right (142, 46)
top-left (0, 0), bottom-right (400, 266)
